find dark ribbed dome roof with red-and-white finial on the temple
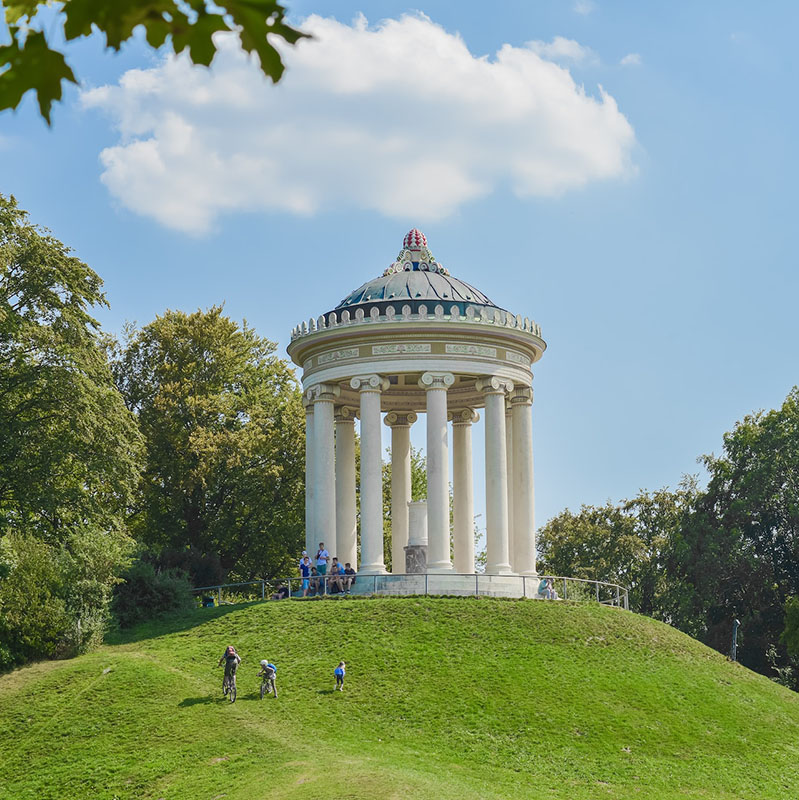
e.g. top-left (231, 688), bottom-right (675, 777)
top-left (334, 228), bottom-right (498, 313)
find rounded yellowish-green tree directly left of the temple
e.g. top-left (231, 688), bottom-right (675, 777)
top-left (114, 307), bottom-right (305, 579)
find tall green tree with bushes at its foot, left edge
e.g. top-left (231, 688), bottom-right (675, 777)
top-left (0, 195), bottom-right (141, 664)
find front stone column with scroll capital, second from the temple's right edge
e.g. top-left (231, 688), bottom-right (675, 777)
top-left (476, 377), bottom-right (513, 575)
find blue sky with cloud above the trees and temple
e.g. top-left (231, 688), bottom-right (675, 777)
top-left (0, 0), bottom-right (799, 536)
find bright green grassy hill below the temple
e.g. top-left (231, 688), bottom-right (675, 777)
top-left (0, 598), bottom-right (799, 800)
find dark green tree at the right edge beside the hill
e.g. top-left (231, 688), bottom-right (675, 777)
top-left (668, 388), bottom-right (799, 674)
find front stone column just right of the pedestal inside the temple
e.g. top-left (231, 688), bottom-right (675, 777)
top-left (419, 372), bottom-right (455, 572)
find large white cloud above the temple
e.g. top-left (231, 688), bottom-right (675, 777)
top-left (82, 16), bottom-right (635, 233)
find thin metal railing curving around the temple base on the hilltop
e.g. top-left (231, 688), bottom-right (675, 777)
top-left (193, 572), bottom-right (630, 611)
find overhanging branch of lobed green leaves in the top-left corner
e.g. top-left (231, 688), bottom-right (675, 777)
top-left (0, 0), bottom-right (307, 125)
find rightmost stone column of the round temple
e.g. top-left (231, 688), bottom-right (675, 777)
top-left (511, 386), bottom-right (536, 575)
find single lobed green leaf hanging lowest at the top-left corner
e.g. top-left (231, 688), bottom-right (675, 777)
top-left (0, 29), bottom-right (77, 125)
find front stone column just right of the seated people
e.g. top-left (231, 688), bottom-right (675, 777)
top-left (350, 375), bottom-right (388, 575)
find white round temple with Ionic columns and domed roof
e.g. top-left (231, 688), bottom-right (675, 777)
top-left (288, 229), bottom-right (546, 575)
